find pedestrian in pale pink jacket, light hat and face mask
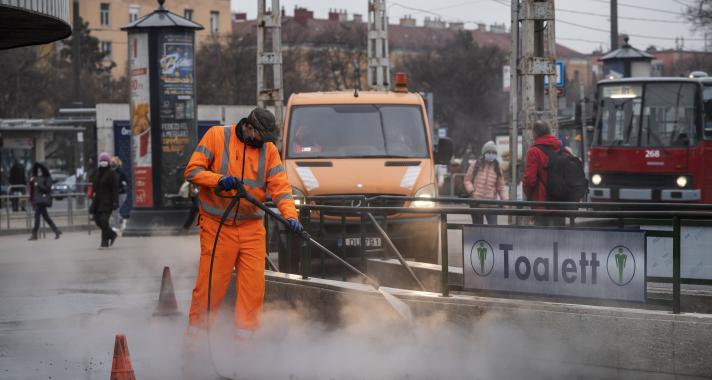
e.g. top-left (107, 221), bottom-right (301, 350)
top-left (464, 141), bottom-right (509, 225)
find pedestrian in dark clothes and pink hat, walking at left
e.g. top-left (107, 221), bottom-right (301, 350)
top-left (89, 152), bottom-right (119, 247)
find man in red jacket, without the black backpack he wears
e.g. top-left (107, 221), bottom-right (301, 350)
top-left (522, 120), bottom-right (570, 226)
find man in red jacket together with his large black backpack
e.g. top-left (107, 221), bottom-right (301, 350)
top-left (522, 120), bottom-right (588, 226)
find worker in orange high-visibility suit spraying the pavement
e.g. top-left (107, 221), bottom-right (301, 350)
top-left (185, 108), bottom-right (303, 339)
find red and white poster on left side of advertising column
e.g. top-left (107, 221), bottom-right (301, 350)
top-left (129, 33), bottom-right (153, 208)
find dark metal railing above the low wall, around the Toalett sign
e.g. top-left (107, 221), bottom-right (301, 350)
top-left (272, 196), bottom-right (712, 314)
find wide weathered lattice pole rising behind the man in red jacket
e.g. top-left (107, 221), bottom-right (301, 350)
top-left (510, 0), bottom-right (563, 205)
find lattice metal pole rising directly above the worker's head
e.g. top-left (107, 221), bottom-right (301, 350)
top-left (257, 0), bottom-right (284, 128)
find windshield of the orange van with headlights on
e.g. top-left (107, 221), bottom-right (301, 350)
top-left (287, 104), bottom-right (428, 158)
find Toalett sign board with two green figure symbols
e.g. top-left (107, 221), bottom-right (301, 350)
top-left (462, 225), bottom-right (646, 302)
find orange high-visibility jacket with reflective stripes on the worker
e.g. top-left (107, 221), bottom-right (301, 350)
top-left (184, 124), bottom-right (297, 225)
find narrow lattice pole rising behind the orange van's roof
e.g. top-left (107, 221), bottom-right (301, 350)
top-left (367, 0), bottom-right (391, 91)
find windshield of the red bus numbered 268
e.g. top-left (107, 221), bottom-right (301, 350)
top-left (595, 83), bottom-right (697, 147)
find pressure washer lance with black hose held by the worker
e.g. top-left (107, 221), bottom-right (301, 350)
top-left (213, 182), bottom-right (413, 324)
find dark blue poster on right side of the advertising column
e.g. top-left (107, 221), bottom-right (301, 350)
top-left (159, 33), bottom-right (196, 206)
